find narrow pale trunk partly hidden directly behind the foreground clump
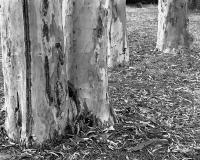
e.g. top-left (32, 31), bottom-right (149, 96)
top-left (108, 0), bottom-right (129, 67)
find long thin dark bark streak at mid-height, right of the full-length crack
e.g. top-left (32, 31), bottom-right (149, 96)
top-left (44, 56), bottom-right (53, 105)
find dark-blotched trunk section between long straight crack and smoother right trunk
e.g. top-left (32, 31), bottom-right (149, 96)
top-left (29, 0), bottom-right (75, 142)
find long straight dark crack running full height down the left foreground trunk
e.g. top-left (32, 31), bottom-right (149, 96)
top-left (22, 0), bottom-right (32, 143)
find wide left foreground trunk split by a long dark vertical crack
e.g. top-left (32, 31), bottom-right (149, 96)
top-left (1, 0), bottom-right (77, 144)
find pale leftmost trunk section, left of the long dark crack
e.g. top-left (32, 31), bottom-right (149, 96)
top-left (1, 0), bottom-right (25, 142)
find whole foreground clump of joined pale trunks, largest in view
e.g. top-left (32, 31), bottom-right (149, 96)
top-left (1, 0), bottom-right (115, 144)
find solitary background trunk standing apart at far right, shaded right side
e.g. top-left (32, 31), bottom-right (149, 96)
top-left (156, 0), bottom-right (191, 53)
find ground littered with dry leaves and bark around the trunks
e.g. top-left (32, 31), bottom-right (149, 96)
top-left (0, 6), bottom-right (200, 160)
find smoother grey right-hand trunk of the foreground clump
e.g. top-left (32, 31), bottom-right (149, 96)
top-left (69, 0), bottom-right (114, 125)
